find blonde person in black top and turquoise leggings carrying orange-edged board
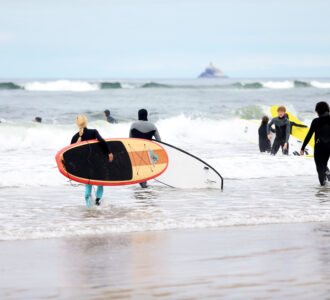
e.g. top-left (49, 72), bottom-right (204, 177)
top-left (71, 115), bottom-right (113, 207)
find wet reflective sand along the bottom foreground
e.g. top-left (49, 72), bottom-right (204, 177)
top-left (0, 223), bottom-right (330, 300)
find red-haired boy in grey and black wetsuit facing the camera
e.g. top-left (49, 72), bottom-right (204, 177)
top-left (267, 106), bottom-right (290, 155)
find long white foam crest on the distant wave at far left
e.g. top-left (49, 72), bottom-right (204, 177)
top-left (24, 80), bottom-right (99, 92)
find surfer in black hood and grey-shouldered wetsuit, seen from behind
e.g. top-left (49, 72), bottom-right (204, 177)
top-left (129, 108), bottom-right (161, 188)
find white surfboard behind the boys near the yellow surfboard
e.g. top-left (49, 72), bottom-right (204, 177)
top-left (240, 119), bottom-right (314, 156)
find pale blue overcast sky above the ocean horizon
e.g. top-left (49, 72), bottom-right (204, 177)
top-left (0, 0), bottom-right (330, 78)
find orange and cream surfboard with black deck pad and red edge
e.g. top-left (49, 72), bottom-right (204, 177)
top-left (55, 138), bottom-right (168, 185)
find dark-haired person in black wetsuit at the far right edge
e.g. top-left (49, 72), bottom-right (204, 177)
top-left (300, 102), bottom-right (330, 186)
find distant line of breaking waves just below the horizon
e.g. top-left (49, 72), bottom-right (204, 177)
top-left (0, 80), bottom-right (330, 92)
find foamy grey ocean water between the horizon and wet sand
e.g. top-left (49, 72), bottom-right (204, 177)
top-left (0, 78), bottom-right (330, 240)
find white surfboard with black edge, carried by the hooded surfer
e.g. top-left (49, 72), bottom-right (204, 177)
top-left (154, 141), bottom-right (223, 189)
